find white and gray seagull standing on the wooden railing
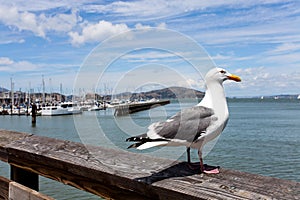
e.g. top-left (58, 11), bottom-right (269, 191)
top-left (126, 68), bottom-right (241, 173)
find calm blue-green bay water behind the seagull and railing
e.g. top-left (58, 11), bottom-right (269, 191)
top-left (0, 99), bottom-right (300, 199)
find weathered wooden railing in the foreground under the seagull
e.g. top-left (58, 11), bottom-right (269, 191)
top-left (0, 130), bottom-right (300, 200)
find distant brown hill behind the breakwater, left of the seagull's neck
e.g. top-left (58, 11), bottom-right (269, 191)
top-left (115, 87), bottom-right (204, 100)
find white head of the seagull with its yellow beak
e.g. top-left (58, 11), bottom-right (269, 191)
top-left (205, 68), bottom-right (242, 83)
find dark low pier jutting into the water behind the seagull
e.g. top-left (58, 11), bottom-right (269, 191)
top-left (114, 100), bottom-right (170, 116)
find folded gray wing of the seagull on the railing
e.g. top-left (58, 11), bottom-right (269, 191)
top-left (152, 106), bottom-right (216, 142)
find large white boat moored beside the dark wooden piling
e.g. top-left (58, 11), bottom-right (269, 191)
top-left (41, 102), bottom-right (82, 116)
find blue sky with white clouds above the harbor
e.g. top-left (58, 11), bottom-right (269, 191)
top-left (0, 0), bottom-right (300, 97)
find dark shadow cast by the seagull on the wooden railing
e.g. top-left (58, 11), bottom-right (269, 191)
top-left (135, 162), bottom-right (216, 184)
